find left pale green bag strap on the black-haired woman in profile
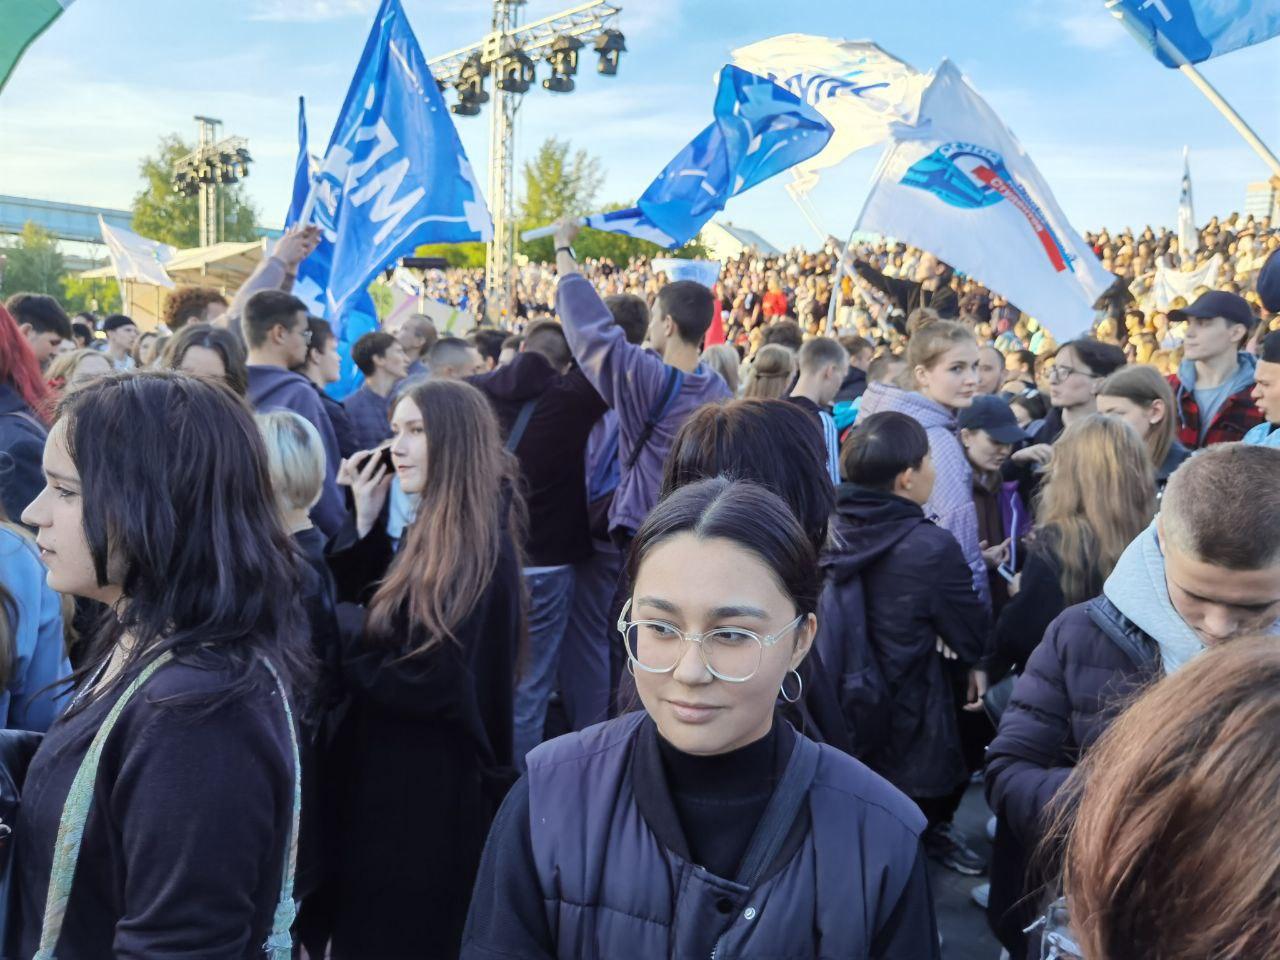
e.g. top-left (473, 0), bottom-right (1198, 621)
top-left (32, 650), bottom-right (173, 960)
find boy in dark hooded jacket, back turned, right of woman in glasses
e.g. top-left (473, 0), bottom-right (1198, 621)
top-left (818, 412), bottom-right (989, 876)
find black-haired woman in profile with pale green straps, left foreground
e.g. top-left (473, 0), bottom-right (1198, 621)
top-left (15, 372), bottom-right (310, 957)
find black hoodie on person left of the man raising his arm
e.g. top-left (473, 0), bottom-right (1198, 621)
top-left (467, 351), bottom-right (608, 567)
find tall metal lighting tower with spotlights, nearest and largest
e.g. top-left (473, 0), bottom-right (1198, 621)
top-left (428, 0), bottom-right (626, 325)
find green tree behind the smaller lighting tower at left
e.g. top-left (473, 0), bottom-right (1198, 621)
top-left (133, 133), bottom-right (257, 248)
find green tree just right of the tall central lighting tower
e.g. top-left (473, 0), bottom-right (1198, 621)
top-left (518, 137), bottom-right (604, 261)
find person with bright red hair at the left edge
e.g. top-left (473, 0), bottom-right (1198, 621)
top-left (0, 306), bottom-right (49, 517)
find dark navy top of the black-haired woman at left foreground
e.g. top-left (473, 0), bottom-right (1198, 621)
top-left (10, 663), bottom-right (294, 960)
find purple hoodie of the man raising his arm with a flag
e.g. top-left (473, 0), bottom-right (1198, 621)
top-left (556, 274), bottom-right (731, 530)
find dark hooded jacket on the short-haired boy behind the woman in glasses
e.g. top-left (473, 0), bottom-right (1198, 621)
top-left (817, 484), bottom-right (989, 797)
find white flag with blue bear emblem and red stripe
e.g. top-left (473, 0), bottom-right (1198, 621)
top-left (858, 60), bottom-right (1115, 342)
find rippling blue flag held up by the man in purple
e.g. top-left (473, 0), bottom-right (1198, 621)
top-left (586, 65), bottom-right (832, 248)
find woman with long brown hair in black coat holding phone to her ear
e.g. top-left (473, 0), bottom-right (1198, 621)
top-left (324, 380), bottom-right (525, 960)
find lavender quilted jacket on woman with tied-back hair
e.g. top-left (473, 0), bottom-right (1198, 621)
top-left (858, 383), bottom-right (991, 609)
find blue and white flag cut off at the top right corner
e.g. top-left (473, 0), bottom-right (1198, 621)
top-left (1106, 0), bottom-right (1280, 68)
